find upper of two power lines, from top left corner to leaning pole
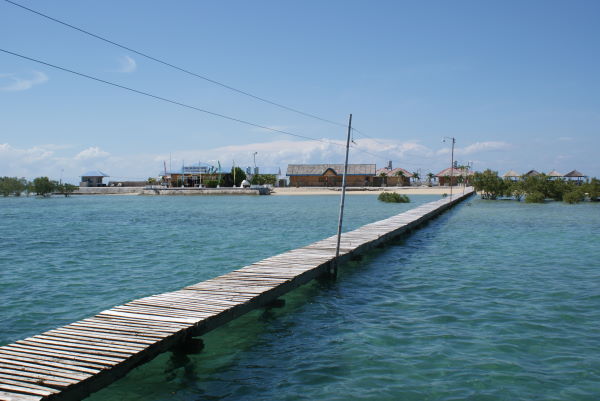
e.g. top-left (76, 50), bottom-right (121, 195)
top-left (4, 0), bottom-right (347, 127)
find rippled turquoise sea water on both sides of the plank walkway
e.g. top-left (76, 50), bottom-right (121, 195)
top-left (0, 196), bottom-right (600, 400)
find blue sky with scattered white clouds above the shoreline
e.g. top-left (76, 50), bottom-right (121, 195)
top-left (0, 0), bottom-right (600, 182)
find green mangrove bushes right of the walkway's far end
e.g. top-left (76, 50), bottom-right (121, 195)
top-left (473, 169), bottom-right (600, 204)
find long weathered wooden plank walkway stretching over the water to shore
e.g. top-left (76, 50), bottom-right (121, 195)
top-left (0, 192), bottom-right (471, 401)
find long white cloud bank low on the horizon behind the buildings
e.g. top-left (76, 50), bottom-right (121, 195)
top-left (0, 138), bottom-right (520, 184)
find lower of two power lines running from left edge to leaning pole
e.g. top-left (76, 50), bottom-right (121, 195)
top-left (0, 48), bottom-right (344, 146)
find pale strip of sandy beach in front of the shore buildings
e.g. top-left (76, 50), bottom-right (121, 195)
top-left (271, 186), bottom-right (472, 195)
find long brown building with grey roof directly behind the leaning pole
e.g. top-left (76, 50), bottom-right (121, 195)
top-left (286, 164), bottom-right (376, 187)
